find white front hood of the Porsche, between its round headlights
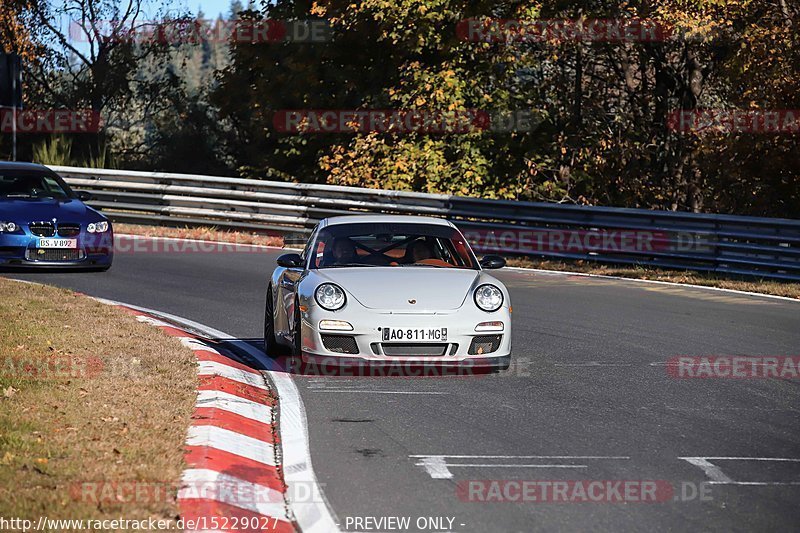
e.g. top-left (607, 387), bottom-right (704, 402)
top-left (317, 267), bottom-right (480, 312)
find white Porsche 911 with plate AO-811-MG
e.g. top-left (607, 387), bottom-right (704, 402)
top-left (264, 215), bottom-right (511, 369)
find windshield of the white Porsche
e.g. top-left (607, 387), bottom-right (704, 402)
top-left (311, 223), bottom-right (479, 270)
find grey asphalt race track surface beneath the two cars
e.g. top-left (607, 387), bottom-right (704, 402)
top-left (3, 242), bottom-right (800, 532)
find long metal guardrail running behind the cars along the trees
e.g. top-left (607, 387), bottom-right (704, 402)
top-left (51, 166), bottom-right (800, 280)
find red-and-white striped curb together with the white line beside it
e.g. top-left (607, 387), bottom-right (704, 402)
top-left (93, 298), bottom-right (339, 533)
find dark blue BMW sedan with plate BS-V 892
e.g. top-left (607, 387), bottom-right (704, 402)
top-left (0, 162), bottom-right (114, 270)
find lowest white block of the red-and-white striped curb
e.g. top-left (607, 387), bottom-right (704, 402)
top-left (178, 468), bottom-right (289, 521)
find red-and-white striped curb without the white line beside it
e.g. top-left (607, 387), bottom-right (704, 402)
top-left (114, 306), bottom-right (296, 532)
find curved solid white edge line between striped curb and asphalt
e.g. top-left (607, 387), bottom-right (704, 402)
top-left (111, 299), bottom-right (340, 533)
